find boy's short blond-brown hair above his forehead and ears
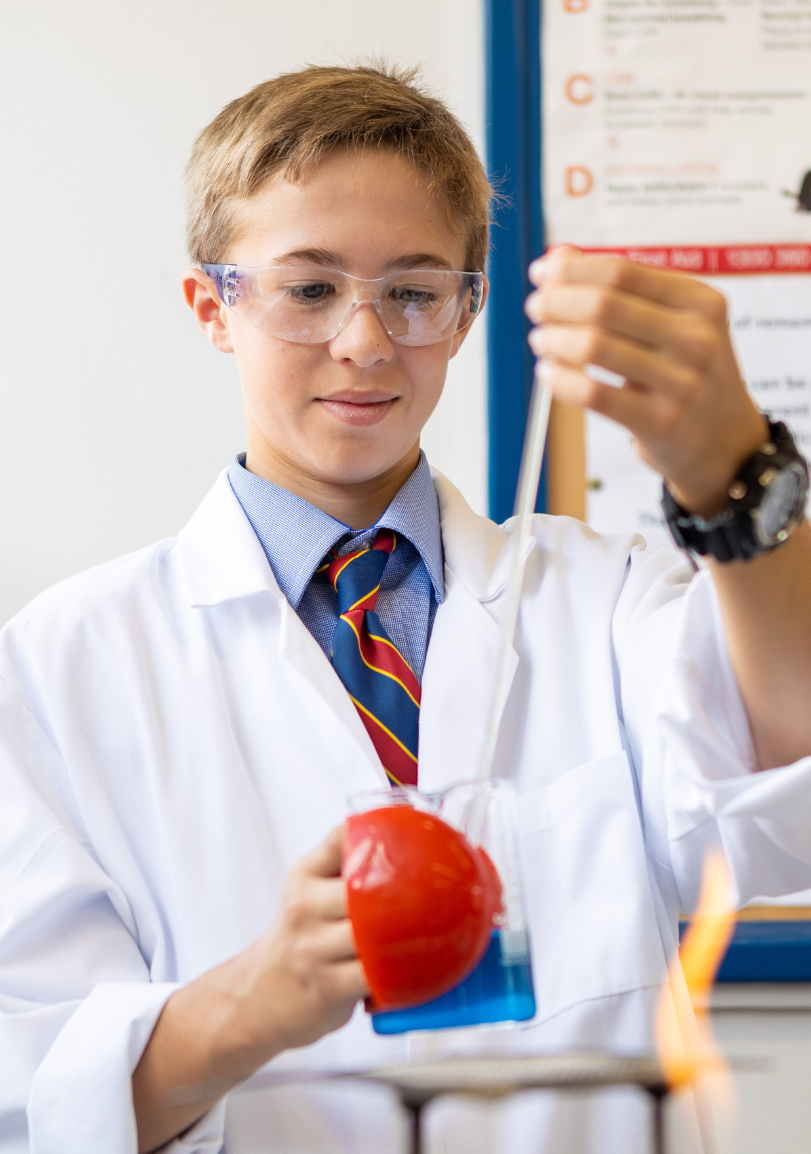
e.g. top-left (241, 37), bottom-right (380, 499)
top-left (186, 66), bottom-right (494, 271)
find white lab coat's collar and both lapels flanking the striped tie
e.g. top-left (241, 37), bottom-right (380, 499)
top-left (180, 472), bottom-right (534, 790)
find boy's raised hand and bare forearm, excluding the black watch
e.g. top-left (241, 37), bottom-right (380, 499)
top-left (526, 248), bottom-right (811, 770)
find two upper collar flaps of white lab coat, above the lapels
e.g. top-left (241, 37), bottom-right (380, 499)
top-left (179, 470), bottom-right (535, 607)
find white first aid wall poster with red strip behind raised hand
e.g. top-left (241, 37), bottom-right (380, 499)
top-left (543, 0), bottom-right (811, 541)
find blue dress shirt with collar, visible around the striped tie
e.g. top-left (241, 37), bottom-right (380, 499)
top-left (228, 452), bottom-right (445, 680)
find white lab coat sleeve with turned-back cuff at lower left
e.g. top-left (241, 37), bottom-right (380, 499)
top-left (0, 679), bottom-right (223, 1154)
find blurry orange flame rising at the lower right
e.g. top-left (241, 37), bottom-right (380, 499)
top-left (656, 850), bottom-right (735, 1087)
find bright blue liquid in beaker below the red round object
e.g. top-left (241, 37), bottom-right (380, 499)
top-left (371, 930), bottom-right (535, 1034)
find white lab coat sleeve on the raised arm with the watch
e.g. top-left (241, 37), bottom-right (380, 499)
top-left (617, 550), bottom-right (811, 912)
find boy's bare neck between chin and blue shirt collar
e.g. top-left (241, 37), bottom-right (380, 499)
top-left (245, 437), bottom-right (420, 529)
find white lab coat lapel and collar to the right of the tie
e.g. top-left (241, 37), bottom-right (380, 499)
top-left (420, 472), bottom-right (535, 792)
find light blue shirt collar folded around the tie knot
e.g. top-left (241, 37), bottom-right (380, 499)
top-left (228, 452), bottom-right (445, 609)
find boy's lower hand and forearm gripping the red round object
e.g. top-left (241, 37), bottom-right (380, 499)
top-left (133, 826), bottom-right (369, 1154)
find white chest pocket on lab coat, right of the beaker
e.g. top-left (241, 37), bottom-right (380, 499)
top-left (519, 752), bottom-right (666, 1021)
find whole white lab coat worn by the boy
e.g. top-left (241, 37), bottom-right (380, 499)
top-left (0, 474), bottom-right (811, 1154)
